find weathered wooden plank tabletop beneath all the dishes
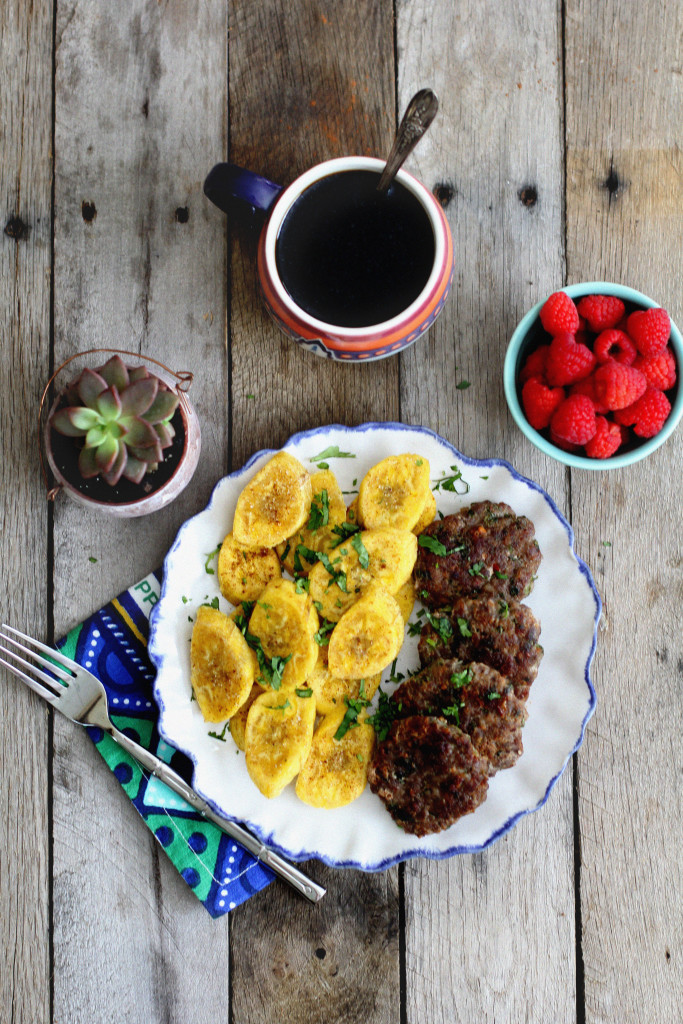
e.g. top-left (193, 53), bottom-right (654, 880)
top-left (0, 0), bottom-right (683, 1024)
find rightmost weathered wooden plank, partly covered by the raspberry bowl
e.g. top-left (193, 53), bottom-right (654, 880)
top-left (566, 0), bottom-right (683, 1024)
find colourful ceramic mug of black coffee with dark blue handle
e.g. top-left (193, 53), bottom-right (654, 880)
top-left (204, 157), bottom-right (453, 361)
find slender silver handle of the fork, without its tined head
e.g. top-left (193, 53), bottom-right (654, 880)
top-left (108, 728), bottom-right (327, 903)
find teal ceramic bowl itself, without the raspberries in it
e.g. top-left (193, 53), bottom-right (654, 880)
top-left (503, 281), bottom-right (683, 469)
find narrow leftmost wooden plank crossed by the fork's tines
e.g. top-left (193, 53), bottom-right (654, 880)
top-left (0, 2), bottom-right (52, 1024)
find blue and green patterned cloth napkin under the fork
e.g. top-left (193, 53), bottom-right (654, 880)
top-left (57, 572), bottom-right (273, 918)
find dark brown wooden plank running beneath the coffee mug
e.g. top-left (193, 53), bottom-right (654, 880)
top-left (229, 0), bottom-right (399, 1024)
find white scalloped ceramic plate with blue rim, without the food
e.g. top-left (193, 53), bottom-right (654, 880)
top-left (150, 423), bottom-right (601, 870)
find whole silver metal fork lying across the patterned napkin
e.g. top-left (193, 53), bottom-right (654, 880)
top-left (0, 624), bottom-right (327, 903)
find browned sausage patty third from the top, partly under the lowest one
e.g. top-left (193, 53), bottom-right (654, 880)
top-left (390, 658), bottom-right (526, 775)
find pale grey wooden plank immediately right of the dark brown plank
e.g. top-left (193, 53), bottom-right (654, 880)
top-left (396, 0), bottom-right (577, 1024)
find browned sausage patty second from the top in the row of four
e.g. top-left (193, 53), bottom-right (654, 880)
top-left (418, 596), bottom-right (543, 700)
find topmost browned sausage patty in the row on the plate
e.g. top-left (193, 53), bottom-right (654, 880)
top-left (415, 502), bottom-right (541, 608)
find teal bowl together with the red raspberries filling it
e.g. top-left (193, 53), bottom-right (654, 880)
top-left (503, 282), bottom-right (683, 469)
